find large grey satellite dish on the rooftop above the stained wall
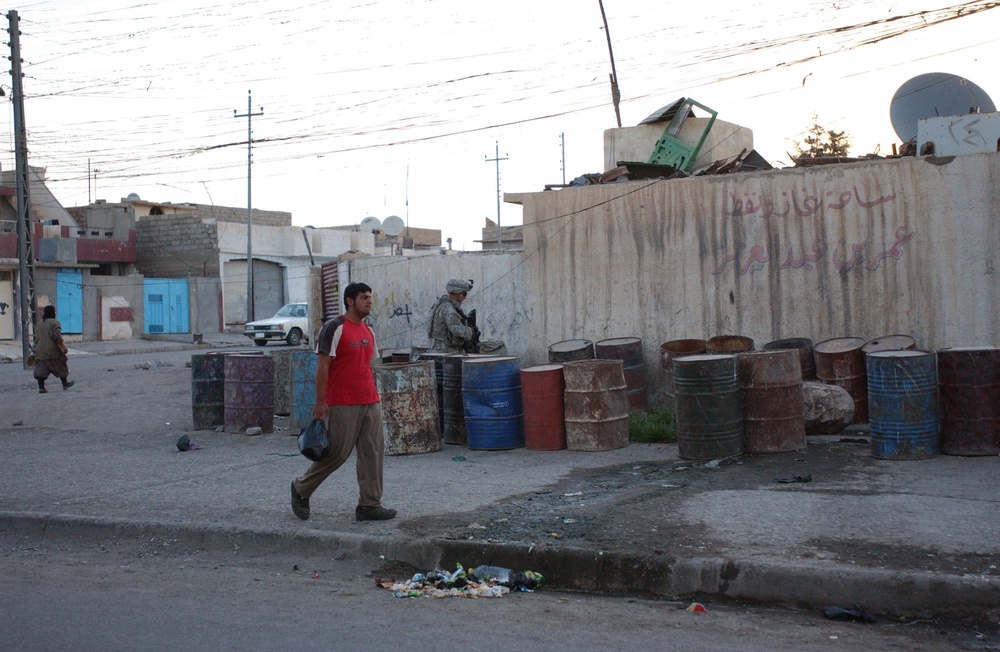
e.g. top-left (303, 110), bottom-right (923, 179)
top-left (889, 72), bottom-right (997, 143)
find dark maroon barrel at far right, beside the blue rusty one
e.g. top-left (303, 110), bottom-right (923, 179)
top-left (937, 347), bottom-right (1000, 455)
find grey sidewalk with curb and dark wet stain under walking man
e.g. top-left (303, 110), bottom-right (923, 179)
top-left (0, 335), bottom-right (1000, 617)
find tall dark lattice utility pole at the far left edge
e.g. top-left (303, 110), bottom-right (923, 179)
top-left (7, 10), bottom-right (36, 369)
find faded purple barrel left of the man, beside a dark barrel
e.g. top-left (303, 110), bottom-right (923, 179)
top-left (224, 353), bottom-right (274, 433)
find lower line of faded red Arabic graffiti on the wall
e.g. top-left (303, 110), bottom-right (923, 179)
top-left (712, 227), bottom-right (916, 276)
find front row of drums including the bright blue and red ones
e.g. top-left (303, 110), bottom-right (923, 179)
top-left (376, 353), bottom-right (629, 455)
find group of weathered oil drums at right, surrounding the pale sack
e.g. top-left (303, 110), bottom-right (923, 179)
top-left (661, 335), bottom-right (1000, 460)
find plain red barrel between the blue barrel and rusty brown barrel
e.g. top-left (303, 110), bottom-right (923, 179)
top-left (521, 364), bottom-right (566, 451)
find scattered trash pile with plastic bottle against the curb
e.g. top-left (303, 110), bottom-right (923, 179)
top-left (375, 564), bottom-right (545, 598)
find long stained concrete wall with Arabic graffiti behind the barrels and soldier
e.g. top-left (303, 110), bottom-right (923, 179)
top-left (349, 154), bottom-right (1000, 408)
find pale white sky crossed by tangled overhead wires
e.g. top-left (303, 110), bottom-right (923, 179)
top-left (0, 0), bottom-right (1000, 250)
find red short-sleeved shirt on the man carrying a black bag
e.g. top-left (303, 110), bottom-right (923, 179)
top-left (316, 315), bottom-right (379, 405)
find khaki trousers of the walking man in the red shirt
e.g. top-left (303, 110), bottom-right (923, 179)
top-left (295, 403), bottom-right (385, 507)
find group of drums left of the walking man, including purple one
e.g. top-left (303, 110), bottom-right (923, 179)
top-left (191, 349), bottom-right (316, 433)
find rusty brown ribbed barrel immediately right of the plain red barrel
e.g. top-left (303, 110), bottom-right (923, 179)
top-left (563, 360), bottom-right (628, 451)
